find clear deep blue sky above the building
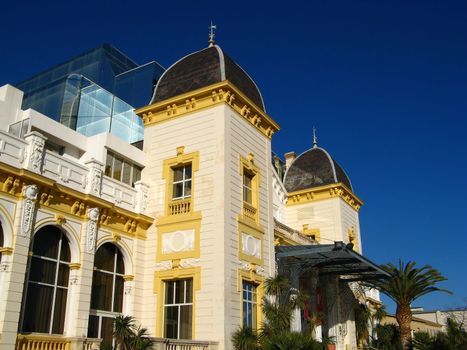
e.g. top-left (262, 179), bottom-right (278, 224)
top-left (0, 0), bottom-right (467, 309)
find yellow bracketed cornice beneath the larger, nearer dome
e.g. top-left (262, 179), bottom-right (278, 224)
top-left (135, 80), bottom-right (280, 138)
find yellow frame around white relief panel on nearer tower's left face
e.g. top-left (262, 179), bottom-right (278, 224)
top-left (156, 212), bottom-right (201, 262)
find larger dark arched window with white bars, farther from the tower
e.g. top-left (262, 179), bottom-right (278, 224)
top-left (21, 226), bottom-right (70, 334)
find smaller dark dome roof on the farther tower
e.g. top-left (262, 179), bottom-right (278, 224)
top-left (284, 147), bottom-right (353, 192)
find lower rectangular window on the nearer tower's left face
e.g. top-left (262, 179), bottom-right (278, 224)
top-left (164, 278), bottom-right (193, 339)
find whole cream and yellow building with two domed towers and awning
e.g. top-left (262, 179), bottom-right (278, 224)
top-left (0, 42), bottom-right (384, 350)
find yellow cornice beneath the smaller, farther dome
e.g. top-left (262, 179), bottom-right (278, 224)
top-left (287, 182), bottom-right (363, 212)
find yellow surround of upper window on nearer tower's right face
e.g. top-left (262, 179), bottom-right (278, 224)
top-left (239, 153), bottom-right (261, 224)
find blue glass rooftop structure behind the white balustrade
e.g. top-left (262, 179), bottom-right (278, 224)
top-left (16, 44), bottom-right (164, 143)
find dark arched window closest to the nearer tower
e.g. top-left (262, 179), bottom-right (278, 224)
top-left (88, 243), bottom-right (125, 344)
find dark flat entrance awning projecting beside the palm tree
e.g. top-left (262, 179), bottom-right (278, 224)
top-left (276, 242), bottom-right (390, 282)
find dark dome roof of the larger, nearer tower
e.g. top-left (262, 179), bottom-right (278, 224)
top-left (150, 45), bottom-right (265, 111)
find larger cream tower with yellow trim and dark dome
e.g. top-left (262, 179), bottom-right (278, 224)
top-left (136, 44), bottom-right (279, 349)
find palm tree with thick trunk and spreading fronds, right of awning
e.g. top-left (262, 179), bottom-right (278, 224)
top-left (371, 260), bottom-right (451, 349)
